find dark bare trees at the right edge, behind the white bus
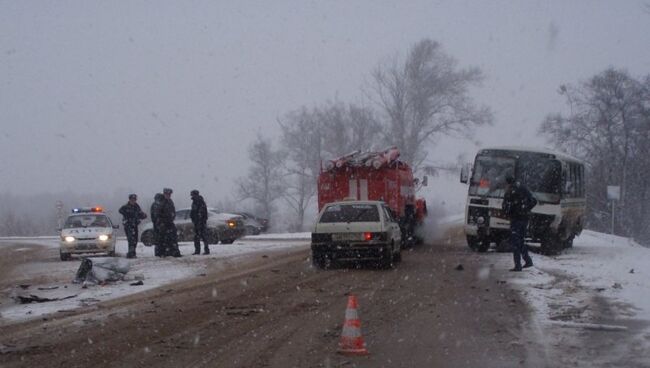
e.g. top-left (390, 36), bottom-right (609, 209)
top-left (540, 68), bottom-right (650, 242)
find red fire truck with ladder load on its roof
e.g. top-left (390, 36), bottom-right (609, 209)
top-left (318, 147), bottom-right (427, 243)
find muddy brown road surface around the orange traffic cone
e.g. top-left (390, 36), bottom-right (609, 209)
top-left (0, 236), bottom-right (543, 367)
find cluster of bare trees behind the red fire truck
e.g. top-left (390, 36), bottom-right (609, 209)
top-left (237, 39), bottom-right (493, 231)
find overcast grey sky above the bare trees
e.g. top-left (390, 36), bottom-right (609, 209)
top-left (0, 0), bottom-right (650, 206)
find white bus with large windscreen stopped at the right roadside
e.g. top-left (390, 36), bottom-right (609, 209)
top-left (460, 147), bottom-right (586, 253)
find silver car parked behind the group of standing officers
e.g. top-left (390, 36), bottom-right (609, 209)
top-left (140, 208), bottom-right (246, 246)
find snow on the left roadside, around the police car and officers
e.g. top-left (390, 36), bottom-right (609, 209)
top-left (0, 233), bottom-right (311, 321)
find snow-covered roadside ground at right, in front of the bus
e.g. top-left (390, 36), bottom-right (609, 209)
top-left (498, 231), bottom-right (650, 367)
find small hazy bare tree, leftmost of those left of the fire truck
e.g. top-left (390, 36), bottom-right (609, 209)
top-left (237, 135), bottom-right (285, 218)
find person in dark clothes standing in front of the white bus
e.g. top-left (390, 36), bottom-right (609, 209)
top-left (502, 175), bottom-right (537, 272)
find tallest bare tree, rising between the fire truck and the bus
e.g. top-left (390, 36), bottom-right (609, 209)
top-left (371, 39), bottom-right (492, 170)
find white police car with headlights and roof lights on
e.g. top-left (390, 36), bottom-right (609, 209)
top-left (59, 207), bottom-right (119, 261)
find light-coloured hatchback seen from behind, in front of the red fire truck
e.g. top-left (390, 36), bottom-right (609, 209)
top-left (311, 201), bottom-right (402, 268)
